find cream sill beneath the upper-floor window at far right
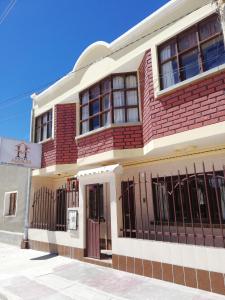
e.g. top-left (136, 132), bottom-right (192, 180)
top-left (156, 64), bottom-right (225, 99)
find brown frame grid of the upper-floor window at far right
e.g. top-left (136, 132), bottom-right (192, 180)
top-left (157, 13), bottom-right (223, 91)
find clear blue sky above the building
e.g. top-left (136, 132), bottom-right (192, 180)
top-left (0, 0), bottom-right (168, 140)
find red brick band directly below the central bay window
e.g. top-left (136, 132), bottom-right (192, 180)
top-left (77, 125), bottom-right (143, 158)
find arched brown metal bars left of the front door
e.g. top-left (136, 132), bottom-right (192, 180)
top-left (30, 181), bottom-right (79, 231)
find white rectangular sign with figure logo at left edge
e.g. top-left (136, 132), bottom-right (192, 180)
top-left (0, 138), bottom-right (41, 169)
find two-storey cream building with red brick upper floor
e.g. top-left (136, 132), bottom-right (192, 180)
top-left (29, 0), bottom-right (225, 294)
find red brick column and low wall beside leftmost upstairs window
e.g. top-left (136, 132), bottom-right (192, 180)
top-left (42, 104), bottom-right (77, 168)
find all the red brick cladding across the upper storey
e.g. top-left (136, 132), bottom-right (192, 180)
top-left (42, 51), bottom-right (225, 167)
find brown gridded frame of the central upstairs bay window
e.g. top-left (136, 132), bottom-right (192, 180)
top-left (79, 72), bottom-right (140, 135)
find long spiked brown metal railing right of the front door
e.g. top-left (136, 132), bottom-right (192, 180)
top-left (120, 163), bottom-right (225, 247)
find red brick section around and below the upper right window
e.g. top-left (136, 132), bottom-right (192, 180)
top-left (139, 51), bottom-right (225, 144)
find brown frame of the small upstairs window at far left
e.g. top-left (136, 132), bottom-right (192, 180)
top-left (34, 109), bottom-right (53, 143)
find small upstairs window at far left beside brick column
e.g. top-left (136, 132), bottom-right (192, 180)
top-left (35, 110), bottom-right (52, 143)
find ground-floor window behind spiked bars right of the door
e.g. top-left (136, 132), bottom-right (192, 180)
top-left (152, 171), bottom-right (225, 224)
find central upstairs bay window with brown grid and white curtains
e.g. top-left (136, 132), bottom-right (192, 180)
top-left (80, 73), bottom-right (139, 134)
